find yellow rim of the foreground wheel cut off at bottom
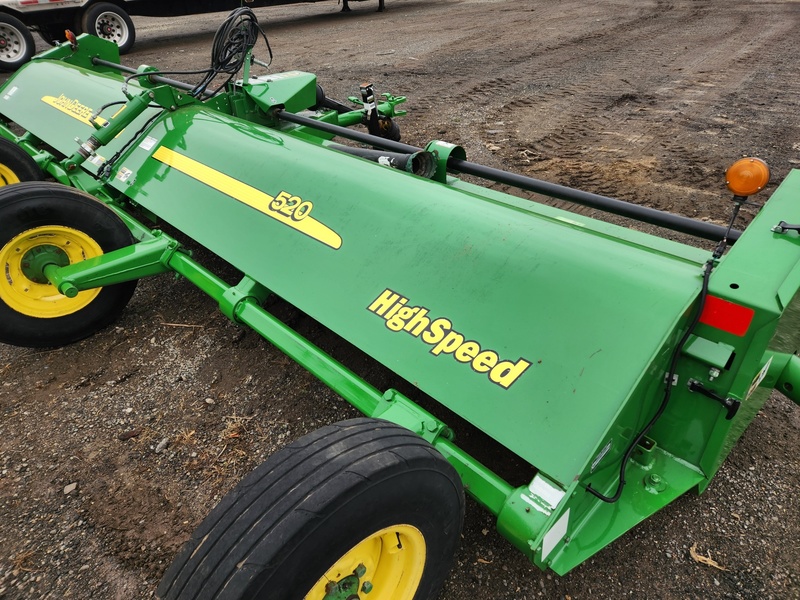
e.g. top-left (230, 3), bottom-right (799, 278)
top-left (305, 525), bottom-right (426, 600)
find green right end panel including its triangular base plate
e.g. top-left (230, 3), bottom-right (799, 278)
top-left (530, 171), bottom-right (800, 574)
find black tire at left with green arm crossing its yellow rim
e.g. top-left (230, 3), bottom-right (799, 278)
top-left (0, 182), bottom-right (136, 348)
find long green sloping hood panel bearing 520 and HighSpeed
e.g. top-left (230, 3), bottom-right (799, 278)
top-left (103, 107), bottom-right (704, 482)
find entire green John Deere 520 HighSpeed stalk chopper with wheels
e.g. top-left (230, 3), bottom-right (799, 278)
top-left (0, 9), bottom-right (800, 600)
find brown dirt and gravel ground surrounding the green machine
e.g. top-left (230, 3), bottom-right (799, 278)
top-left (0, 0), bottom-right (800, 600)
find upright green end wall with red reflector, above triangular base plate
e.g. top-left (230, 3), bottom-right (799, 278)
top-left (636, 171), bottom-right (800, 490)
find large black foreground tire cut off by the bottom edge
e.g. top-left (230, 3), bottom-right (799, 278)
top-left (158, 418), bottom-right (464, 600)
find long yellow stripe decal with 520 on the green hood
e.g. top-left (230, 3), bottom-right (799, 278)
top-left (153, 146), bottom-right (342, 250)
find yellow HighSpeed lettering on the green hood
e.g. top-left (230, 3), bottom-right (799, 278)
top-left (367, 288), bottom-right (531, 389)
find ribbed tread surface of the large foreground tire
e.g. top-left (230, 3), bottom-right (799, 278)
top-left (159, 418), bottom-right (463, 599)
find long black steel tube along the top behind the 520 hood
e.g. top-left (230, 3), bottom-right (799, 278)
top-left (275, 110), bottom-right (742, 244)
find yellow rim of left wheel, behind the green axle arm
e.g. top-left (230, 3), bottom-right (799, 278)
top-left (0, 225), bottom-right (103, 319)
